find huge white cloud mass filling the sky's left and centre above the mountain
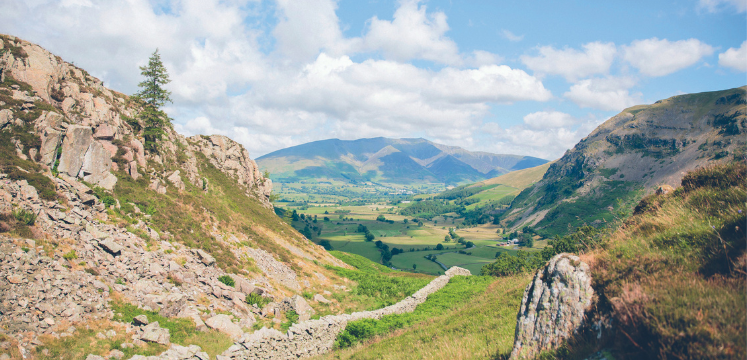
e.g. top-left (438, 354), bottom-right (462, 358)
top-left (0, 0), bottom-right (552, 156)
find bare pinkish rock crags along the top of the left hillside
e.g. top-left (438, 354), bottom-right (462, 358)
top-left (0, 35), bottom-right (272, 208)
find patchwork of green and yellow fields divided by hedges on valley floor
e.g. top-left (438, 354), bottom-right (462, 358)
top-left (284, 202), bottom-right (546, 275)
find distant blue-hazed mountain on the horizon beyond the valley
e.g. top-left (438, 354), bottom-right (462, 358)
top-left (257, 137), bottom-right (547, 184)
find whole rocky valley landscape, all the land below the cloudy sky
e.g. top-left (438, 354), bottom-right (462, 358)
top-left (0, 21), bottom-right (747, 360)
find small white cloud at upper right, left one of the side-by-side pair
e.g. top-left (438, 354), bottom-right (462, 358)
top-left (521, 42), bottom-right (617, 82)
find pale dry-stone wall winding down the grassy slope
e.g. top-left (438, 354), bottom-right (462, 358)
top-left (218, 267), bottom-right (471, 360)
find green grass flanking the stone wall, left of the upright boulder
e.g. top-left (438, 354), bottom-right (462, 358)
top-left (316, 252), bottom-right (530, 359)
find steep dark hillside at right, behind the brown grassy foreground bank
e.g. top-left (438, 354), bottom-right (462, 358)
top-left (502, 87), bottom-right (747, 235)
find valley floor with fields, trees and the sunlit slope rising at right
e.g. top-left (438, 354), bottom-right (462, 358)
top-left (275, 164), bottom-right (549, 275)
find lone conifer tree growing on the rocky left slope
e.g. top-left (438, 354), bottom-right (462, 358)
top-left (135, 49), bottom-right (172, 151)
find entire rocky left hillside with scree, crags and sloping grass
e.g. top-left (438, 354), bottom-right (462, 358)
top-left (0, 35), bottom-right (368, 358)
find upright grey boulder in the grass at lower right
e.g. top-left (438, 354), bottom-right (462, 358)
top-left (511, 253), bottom-right (594, 359)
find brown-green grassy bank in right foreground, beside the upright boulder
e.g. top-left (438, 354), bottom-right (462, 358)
top-left (590, 159), bottom-right (747, 359)
